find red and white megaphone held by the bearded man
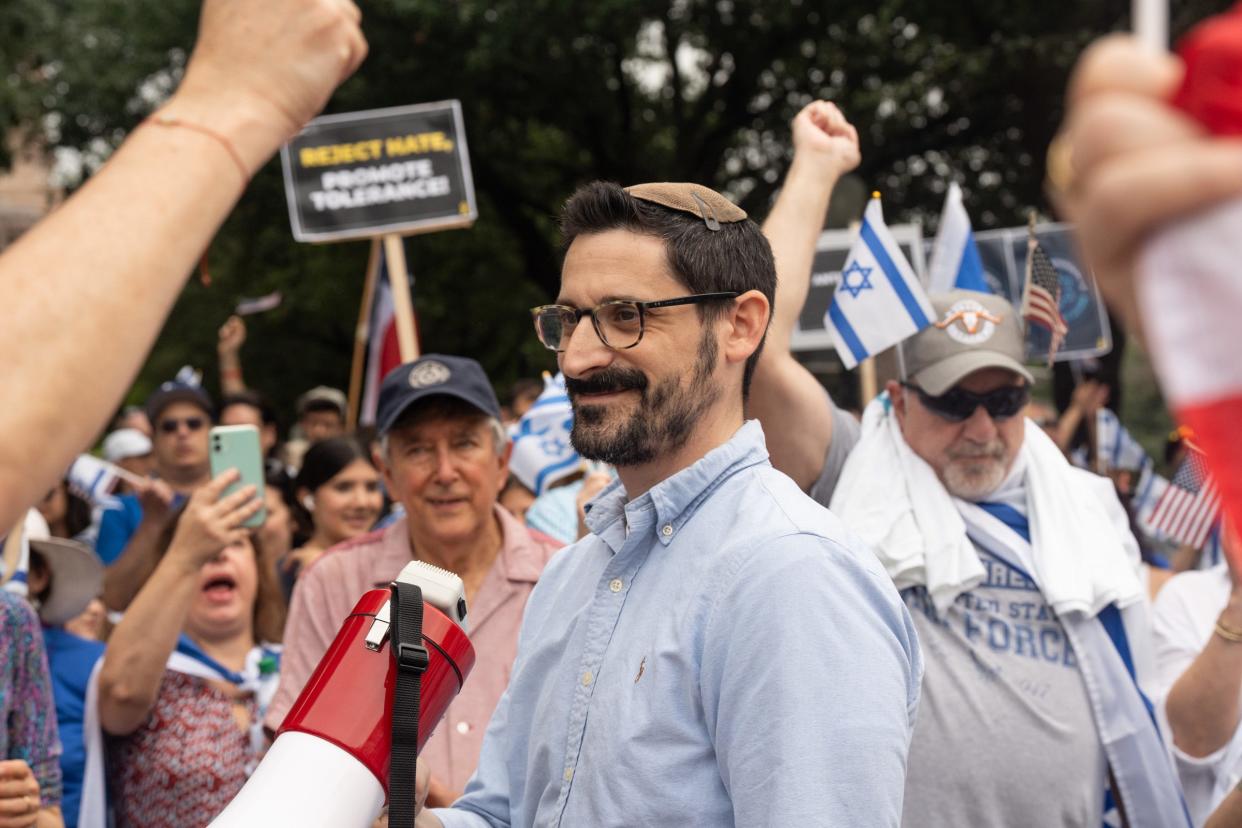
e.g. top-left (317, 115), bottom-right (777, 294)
top-left (211, 561), bottom-right (474, 828)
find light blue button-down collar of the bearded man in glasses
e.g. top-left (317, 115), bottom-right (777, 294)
top-left (586, 420), bottom-right (768, 546)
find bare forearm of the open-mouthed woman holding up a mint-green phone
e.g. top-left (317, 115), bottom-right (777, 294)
top-left (99, 557), bottom-right (197, 735)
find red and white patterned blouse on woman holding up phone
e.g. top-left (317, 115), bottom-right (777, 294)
top-left (108, 670), bottom-right (258, 828)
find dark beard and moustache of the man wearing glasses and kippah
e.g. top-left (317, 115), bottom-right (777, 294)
top-left (565, 326), bottom-right (719, 467)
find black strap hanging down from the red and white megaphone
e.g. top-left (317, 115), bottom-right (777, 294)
top-left (389, 581), bottom-right (428, 828)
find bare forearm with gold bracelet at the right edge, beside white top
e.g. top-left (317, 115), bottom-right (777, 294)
top-left (1165, 636), bottom-right (1242, 756)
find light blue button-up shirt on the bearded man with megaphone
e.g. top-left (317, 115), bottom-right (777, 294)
top-left (432, 422), bottom-right (923, 828)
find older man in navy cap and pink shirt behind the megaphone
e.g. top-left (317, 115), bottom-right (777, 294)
top-left (274, 354), bottom-right (560, 804)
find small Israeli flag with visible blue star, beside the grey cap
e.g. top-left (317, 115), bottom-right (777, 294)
top-left (823, 195), bottom-right (935, 369)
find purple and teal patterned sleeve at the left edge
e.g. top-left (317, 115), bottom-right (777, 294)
top-left (0, 590), bottom-right (61, 808)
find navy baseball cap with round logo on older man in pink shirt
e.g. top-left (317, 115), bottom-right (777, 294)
top-left (375, 354), bottom-right (501, 434)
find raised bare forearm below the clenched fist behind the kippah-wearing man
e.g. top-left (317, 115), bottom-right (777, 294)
top-left (764, 155), bottom-right (837, 350)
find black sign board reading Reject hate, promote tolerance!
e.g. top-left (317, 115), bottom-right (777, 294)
top-left (281, 101), bottom-right (478, 242)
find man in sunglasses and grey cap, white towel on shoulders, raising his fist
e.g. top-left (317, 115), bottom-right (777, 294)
top-left (751, 101), bottom-right (1186, 828)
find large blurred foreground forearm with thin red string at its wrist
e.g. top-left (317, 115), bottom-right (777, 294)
top-left (0, 92), bottom-right (272, 525)
